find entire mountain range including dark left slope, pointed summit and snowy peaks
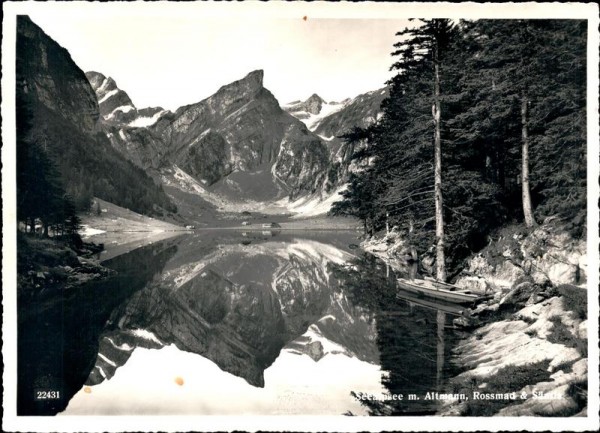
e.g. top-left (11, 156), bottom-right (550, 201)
top-left (18, 14), bottom-right (390, 219)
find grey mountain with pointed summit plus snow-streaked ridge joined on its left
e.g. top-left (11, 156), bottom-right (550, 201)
top-left (88, 70), bottom-right (338, 201)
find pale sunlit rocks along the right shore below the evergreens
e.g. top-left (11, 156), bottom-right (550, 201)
top-left (363, 220), bottom-right (588, 416)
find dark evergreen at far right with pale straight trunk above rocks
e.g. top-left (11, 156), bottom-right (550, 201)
top-left (458, 20), bottom-right (585, 230)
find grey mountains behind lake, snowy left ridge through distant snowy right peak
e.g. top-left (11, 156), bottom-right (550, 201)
top-left (87, 70), bottom-right (390, 212)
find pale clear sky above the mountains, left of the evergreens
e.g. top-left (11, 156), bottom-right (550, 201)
top-left (29, 11), bottom-right (409, 110)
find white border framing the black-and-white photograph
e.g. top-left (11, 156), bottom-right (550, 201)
top-left (2, 1), bottom-right (600, 432)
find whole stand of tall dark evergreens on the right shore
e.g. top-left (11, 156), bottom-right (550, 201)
top-left (336, 20), bottom-right (586, 277)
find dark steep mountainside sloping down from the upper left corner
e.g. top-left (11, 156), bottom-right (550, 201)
top-left (16, 16), bottom-right (174, 214)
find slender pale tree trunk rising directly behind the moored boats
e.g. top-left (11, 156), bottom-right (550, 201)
top-left (432, 59), bottom-right (446, 281)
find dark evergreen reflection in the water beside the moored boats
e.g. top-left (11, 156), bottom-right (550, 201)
top-left (332, 254), bottom-right (464, 415)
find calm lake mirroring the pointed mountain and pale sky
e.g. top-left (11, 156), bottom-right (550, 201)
top-left (19, 230), bottom-right (458, 415)
